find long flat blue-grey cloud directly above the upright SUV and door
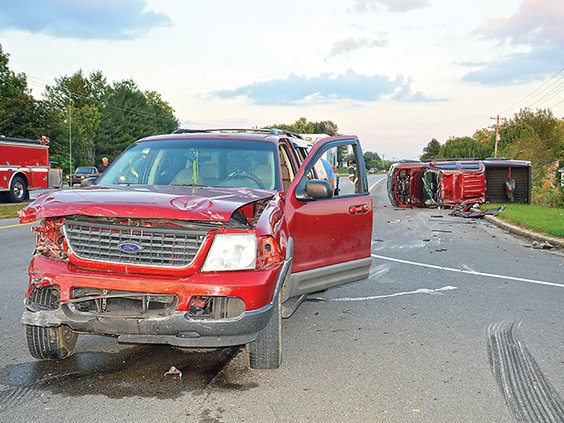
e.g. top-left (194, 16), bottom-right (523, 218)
top-left (213, 70), bottom-right (442, 105)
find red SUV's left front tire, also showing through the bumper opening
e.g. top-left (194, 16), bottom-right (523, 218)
top-left (25, 287), bottom-right (78, 360)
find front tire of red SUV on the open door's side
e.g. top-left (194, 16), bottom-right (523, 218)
top-left (249, 295), bottom-right (282, 369)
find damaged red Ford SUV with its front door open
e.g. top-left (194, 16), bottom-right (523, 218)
top-left (20, 130), bottom-right (372, 368)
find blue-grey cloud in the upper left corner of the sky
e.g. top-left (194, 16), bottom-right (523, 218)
top-left (0, 0), bottom-right (170, 40)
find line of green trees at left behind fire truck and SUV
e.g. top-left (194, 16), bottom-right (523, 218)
top-left (0, 45), bottom-right (179, 173)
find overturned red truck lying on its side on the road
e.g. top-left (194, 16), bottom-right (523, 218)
top-left (388, 159), bottom-right (531, 207)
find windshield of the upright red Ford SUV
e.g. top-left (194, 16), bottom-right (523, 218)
top-left (97, 139), bottom-right (279, 190)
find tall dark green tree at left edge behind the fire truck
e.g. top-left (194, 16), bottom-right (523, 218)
top-left (0, 44), bottom-right (43, 139)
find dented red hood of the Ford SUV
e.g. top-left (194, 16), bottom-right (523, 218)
top-left (20, 186), bottom-right (274, 223)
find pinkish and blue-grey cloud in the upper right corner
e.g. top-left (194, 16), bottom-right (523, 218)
top-left (464, 0), bottom-right (564, 84)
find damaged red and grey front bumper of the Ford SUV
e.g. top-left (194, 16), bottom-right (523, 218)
top-left (22, 255), bottom-right (290, 347)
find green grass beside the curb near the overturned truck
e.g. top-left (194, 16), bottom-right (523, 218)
top-left (481, 204), bottom-right (564, 238)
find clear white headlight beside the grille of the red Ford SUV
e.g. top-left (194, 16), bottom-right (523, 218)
top-left (202, 234), bottom-right (257, 272)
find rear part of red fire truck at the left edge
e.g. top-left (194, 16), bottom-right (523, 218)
top-left (0, 135), bottom-right (62, 203)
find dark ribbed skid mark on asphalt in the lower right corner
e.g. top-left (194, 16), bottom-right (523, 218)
top-left (487, 322), bottom-right (564, 423)
